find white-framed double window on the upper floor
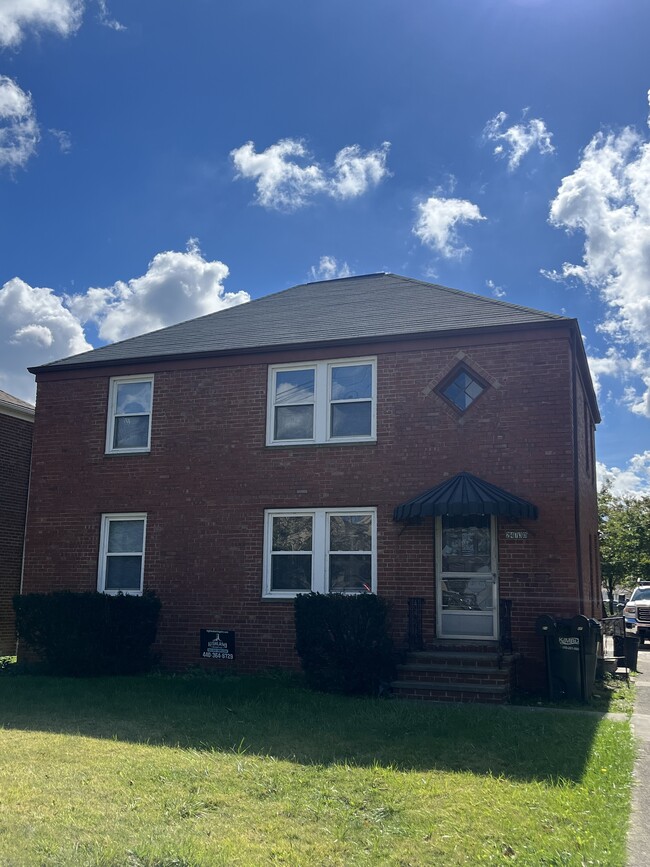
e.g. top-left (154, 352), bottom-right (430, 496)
top-left (266, 358), bottom-right (377, 445)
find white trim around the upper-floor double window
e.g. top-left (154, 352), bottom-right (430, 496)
top-left (266, 356), bottom-right (377, 446)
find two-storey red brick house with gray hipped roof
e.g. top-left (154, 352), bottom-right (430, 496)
top-left (24, 273), bottom-right (600, 698)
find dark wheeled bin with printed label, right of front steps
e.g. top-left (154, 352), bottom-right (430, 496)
top-left (535, 614), bottom-right (600, 702)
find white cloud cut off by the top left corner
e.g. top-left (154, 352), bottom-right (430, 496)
top-left (0, 0), bottom-right (84, 48)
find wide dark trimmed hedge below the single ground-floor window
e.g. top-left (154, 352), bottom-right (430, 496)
top-left (14, 591), bottom-right (160, 677)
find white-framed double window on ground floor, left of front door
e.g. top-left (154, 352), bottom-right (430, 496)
top-left (263, 508), bottom-right (377, 599)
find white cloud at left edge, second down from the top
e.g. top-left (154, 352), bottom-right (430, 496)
top-left (0, 75), bottom-right (39, 170)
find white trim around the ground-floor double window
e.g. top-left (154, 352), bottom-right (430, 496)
top-left (262, 506), bottom-right (377, 599)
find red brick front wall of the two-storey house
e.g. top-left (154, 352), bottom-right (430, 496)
top-left (24, 327), bottom-right (591, 683)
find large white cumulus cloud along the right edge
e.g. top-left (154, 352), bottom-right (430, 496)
top-left (543, 107), bottom-right (650, 417)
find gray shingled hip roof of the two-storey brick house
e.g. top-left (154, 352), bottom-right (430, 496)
top-left (30, 273), bottom-right (568, 373)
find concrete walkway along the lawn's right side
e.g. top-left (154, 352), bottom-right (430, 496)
top-left (627, 644), bottom-right (650, 867)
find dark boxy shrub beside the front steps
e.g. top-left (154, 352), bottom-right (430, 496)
top-left (295, 593), bottom-right (395, 695)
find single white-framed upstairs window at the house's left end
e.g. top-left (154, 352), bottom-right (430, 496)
top-left (106, 376), bottom-right (153, 454)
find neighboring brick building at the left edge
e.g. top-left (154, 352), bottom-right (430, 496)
top-left (0, 391), bottom-right (34, 656)
